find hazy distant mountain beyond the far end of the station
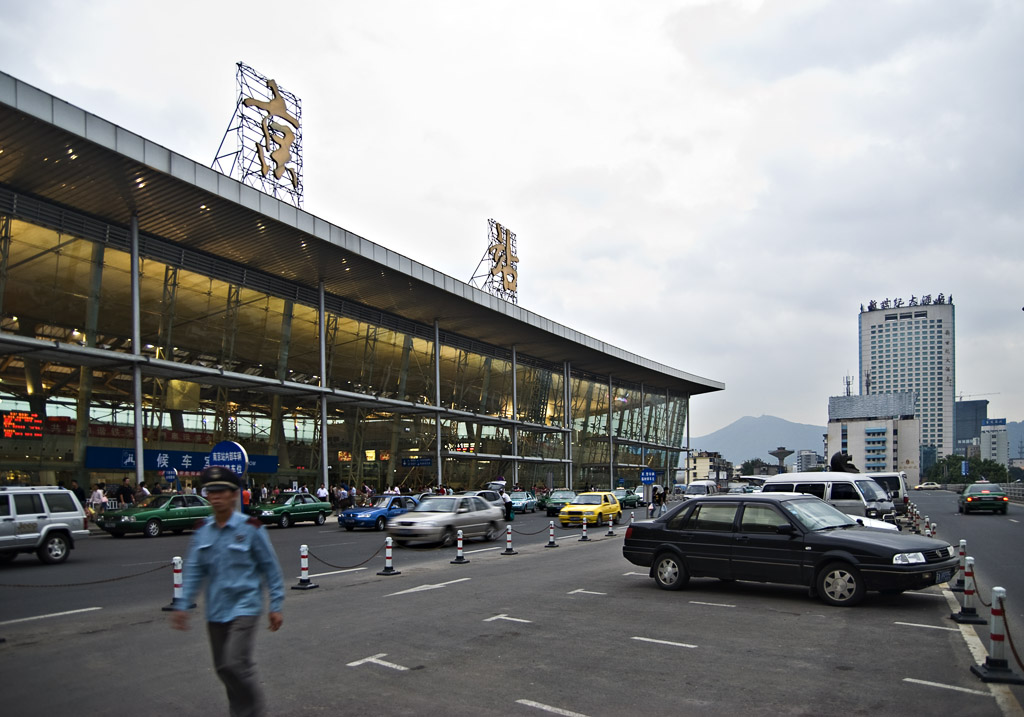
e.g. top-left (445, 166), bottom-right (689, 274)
top-left (690, 416), bottom-right (827, 468)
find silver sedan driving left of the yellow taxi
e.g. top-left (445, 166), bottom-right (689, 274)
top-left (387, 496), bottom-right (505, 547)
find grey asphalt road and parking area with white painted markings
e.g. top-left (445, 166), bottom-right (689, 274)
top-left (0, 496), bottom-right (1024, 716)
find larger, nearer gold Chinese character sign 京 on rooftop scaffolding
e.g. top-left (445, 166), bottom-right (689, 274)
top-left (213, 62), bottom-right (302, 207)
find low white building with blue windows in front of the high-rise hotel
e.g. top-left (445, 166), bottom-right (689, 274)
top-left (826, 391), bottom-right (921, 484)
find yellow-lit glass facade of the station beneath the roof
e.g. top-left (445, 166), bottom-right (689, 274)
top-left (0, 205), bottom-right (689, 489)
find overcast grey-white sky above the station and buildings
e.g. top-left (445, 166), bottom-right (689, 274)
top-left (0, 0), bottom-right (1024, 436)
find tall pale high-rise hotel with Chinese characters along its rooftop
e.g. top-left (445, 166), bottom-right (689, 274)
top-left (860, 294), bottom-right (956, 458)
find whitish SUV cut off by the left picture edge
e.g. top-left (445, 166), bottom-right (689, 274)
top-left (0, 486), bottom-right (89, 564)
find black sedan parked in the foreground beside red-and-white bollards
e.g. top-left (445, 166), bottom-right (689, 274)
top-left (623, 493), bottom-right (957, 605)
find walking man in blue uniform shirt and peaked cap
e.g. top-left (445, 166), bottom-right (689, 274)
top-left (171, 466), bottom-right (285, 717)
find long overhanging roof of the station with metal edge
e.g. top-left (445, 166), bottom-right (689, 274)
top-left (0, 73), bottom-right (725, 395)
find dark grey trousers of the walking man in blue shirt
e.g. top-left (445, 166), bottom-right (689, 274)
top-left (206, 615), bottom-right (264, 717)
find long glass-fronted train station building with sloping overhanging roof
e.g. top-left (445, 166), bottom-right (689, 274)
top-left (0, 73), bottom-right (725, 489)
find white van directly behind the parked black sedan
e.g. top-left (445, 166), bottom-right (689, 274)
top-left (763, 471), bottom-right (896, 520)
